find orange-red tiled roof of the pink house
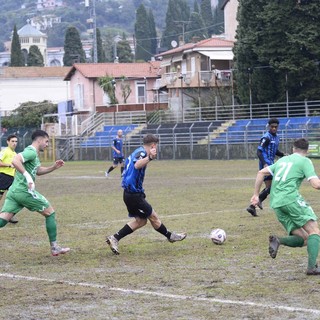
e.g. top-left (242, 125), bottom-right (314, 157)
top-left (64, 61), bottom-right (160, 80)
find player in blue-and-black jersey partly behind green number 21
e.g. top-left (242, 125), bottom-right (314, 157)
top-left (247, 118), bottom-right (285, 217)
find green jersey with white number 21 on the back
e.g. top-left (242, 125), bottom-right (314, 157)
top-left (268, 153), bottom-right (317, 209)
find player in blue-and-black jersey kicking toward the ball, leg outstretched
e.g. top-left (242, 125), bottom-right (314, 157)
top-left (106, 134), bottom-right (187, 254)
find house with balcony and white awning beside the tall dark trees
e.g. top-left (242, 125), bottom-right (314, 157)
top-left (156, 38), bottom-right (234, 110)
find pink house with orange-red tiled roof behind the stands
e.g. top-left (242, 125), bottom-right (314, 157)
top-left (64, 61), bottom-right (160, 113)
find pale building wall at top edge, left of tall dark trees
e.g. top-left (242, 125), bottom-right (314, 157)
top-left (221, 0), bottom-right (239, 41)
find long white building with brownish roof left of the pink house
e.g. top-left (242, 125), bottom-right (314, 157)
top-left (0, 67), bottom-right (70, 115)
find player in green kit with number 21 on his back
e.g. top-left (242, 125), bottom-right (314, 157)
top-left (251, 138), bottom-right (320, 275)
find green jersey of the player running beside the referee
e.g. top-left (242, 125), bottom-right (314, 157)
top-left (10, 145), bottom-right (41, 192)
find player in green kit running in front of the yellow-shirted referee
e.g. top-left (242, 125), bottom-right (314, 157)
top-left (0, 130), bottom-right (70, 256)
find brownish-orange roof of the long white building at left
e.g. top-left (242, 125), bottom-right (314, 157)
top-left (0, 67), bottom-right (70, 79)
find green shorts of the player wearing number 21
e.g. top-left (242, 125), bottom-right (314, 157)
top-left (273, 198), bottom-right (318, 235)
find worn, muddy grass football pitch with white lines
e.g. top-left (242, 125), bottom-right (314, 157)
top-left (0, 160), bottom-right (320, 320)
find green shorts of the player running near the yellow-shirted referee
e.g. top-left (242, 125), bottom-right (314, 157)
top-left (1, 190), bottom-right (50, 214)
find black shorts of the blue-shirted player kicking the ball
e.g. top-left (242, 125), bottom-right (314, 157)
top-left (123, 191), bottom-right (152, 219)
